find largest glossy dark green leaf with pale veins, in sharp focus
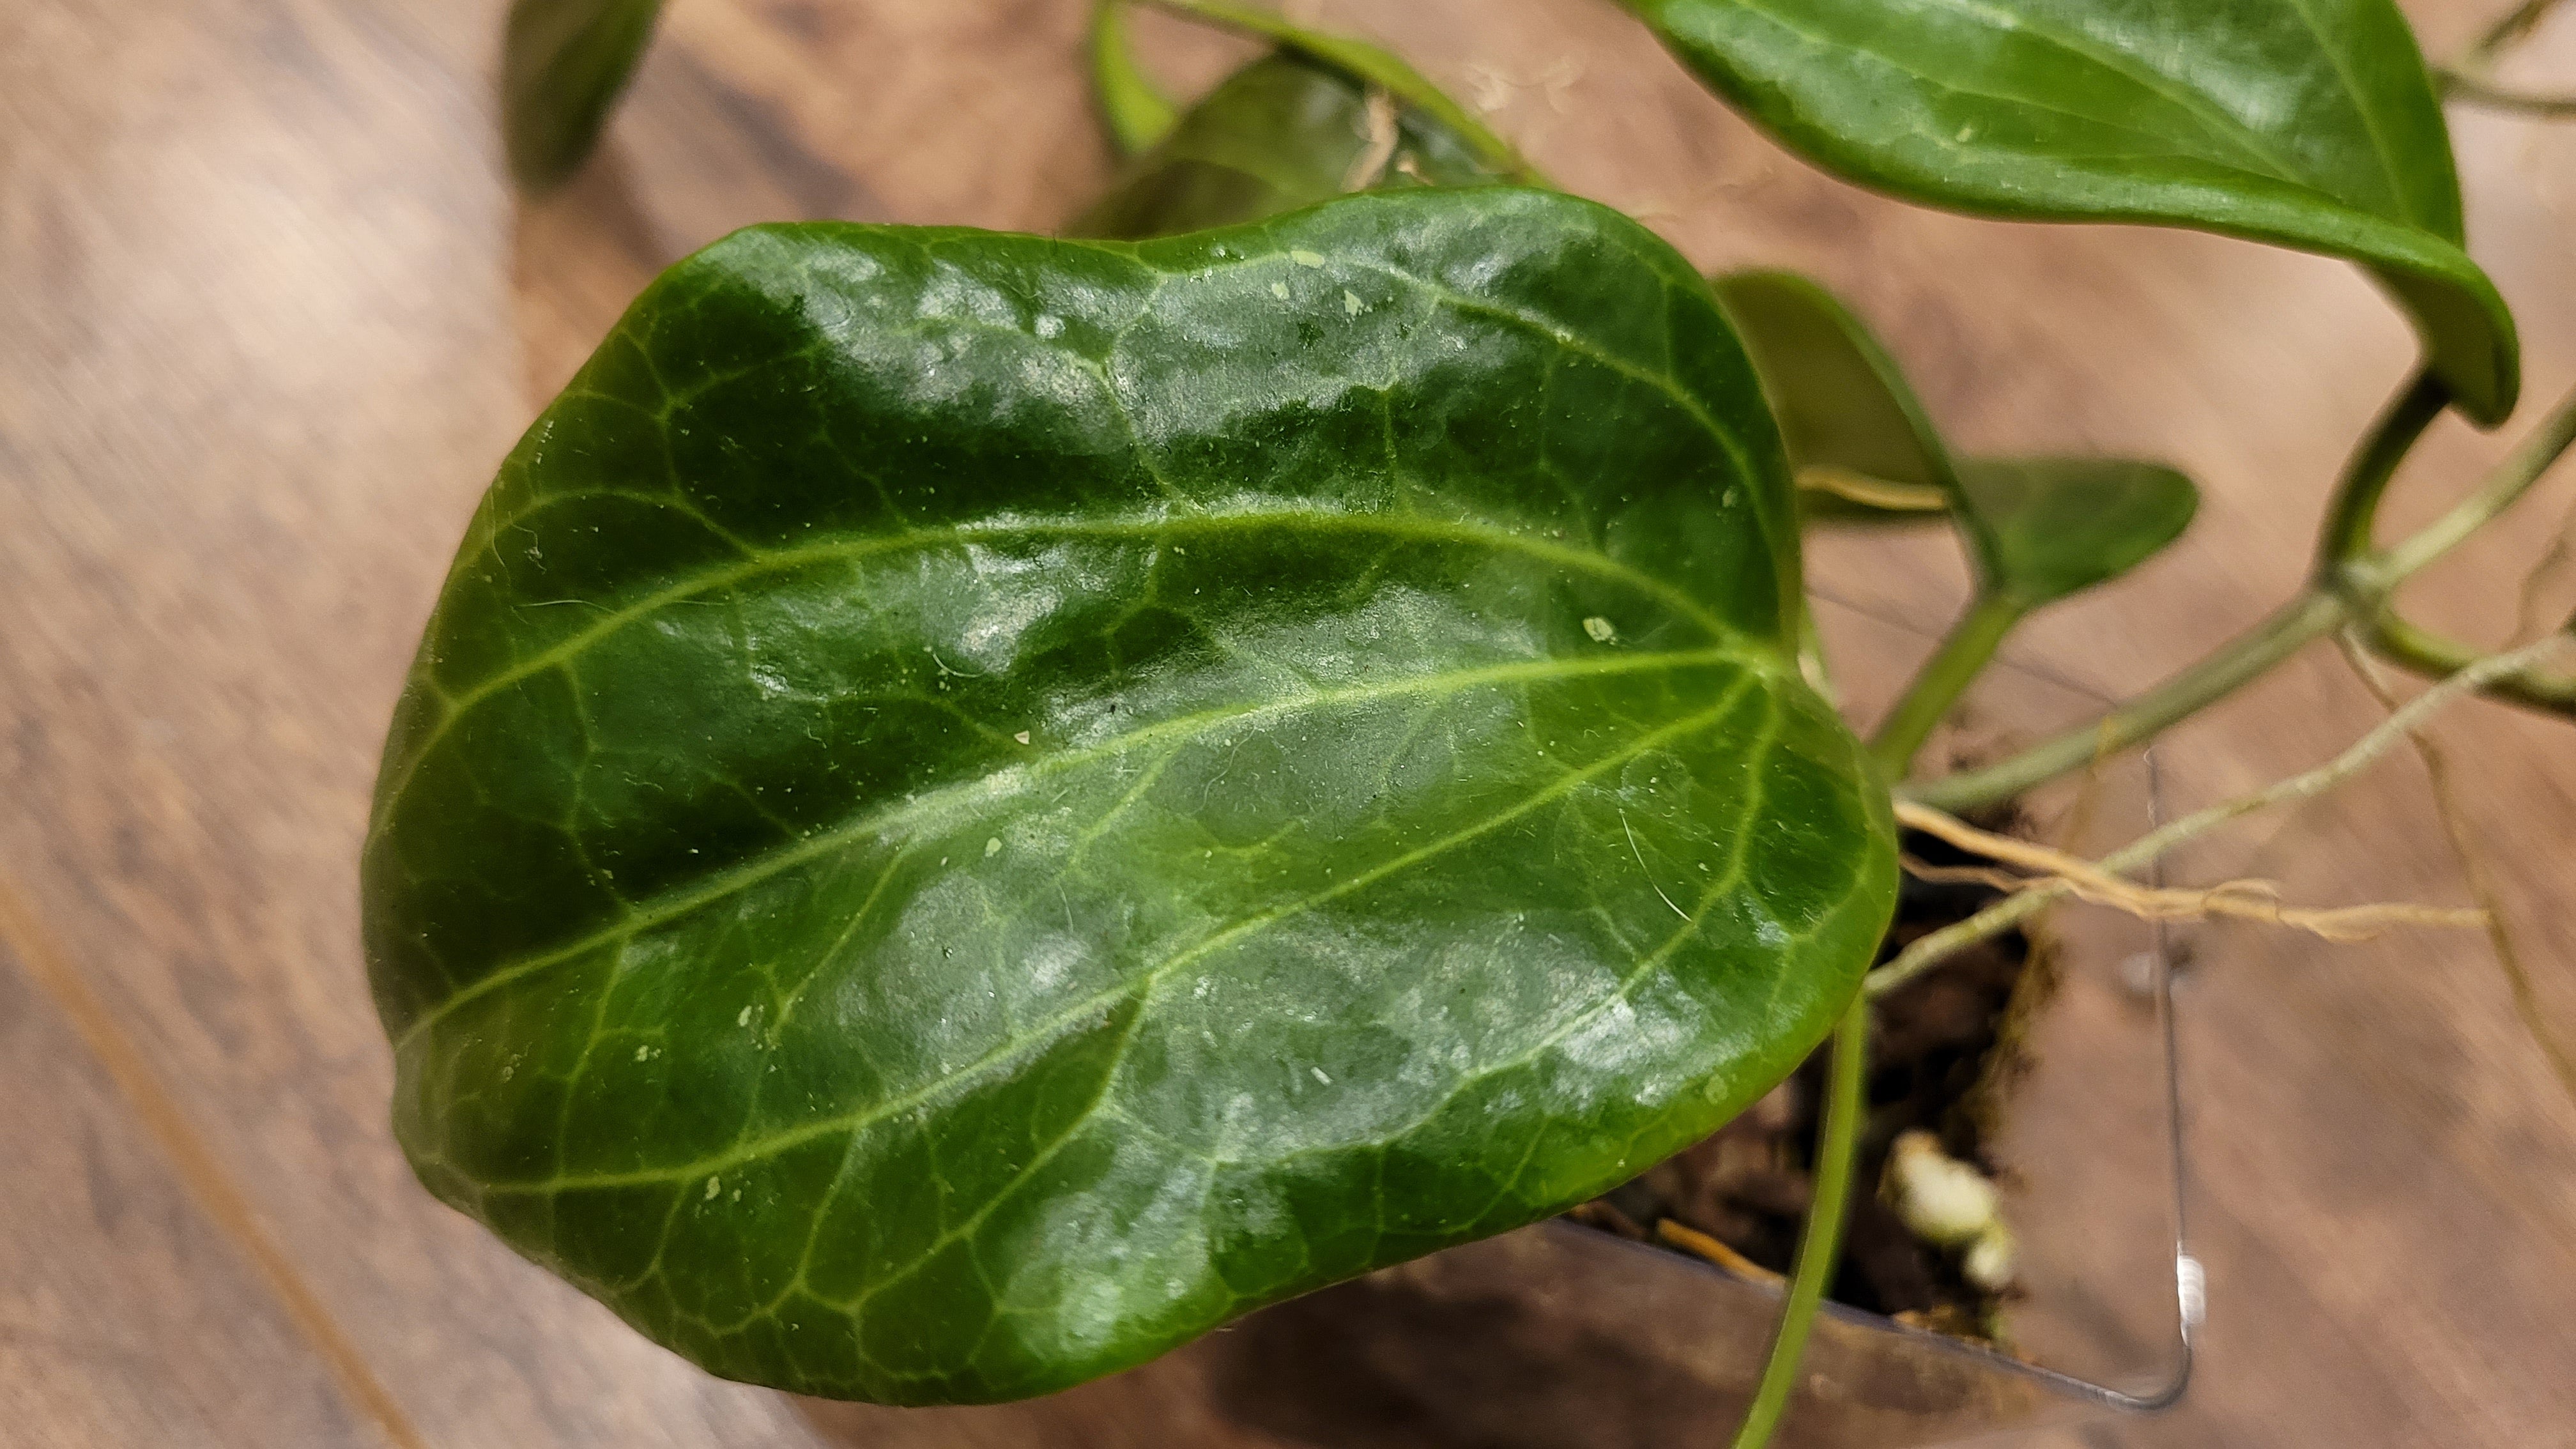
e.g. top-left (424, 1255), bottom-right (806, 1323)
top-left (364, 188), bottom-right (1894, 1402)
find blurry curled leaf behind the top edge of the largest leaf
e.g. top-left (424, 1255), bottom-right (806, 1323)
top-left (1069, 0), bottom-right (1528, 240)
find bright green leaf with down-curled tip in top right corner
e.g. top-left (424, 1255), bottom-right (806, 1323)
top-left (1625, 0), bottom-right (2519, 425)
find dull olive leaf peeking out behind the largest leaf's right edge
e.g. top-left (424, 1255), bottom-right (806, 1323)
top-left (1715, 271), bottom-right (1958, 523)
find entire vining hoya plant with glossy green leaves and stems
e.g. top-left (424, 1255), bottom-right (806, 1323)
top-left (364, 0), bottom-right (2576, 1444)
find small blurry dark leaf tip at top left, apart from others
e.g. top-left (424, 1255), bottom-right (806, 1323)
top-left (500, 0), bottom-right (662, 188)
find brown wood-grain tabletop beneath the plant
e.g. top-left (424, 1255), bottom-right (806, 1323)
top-left (0, 0), bottom-right (2576, 1449)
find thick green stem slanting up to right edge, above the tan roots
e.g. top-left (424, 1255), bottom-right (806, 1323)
top-left (1896, 392), bottom-right (2576, 815)
